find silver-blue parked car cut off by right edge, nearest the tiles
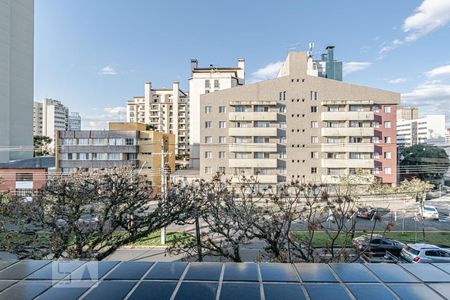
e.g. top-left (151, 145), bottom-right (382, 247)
top-left (400, 244), bottom-right (450, 263)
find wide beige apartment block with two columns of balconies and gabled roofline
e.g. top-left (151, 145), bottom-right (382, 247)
top-left (200, 52), bottom-right (400, 186)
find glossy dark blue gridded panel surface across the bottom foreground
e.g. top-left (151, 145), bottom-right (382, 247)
top-left (0, 260), bottom-right (450, 300)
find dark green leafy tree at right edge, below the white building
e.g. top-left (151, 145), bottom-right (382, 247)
top-left (398, 144), bottom-right (450, 181)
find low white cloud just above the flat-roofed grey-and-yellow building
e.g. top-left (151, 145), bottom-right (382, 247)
top-left (81, 106), bottom-right (127, 130)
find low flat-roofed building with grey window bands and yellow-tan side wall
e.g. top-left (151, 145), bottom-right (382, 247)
top-left (55, 123), bottom-right (175, 191)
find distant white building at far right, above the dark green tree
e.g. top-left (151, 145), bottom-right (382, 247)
top-left (397, 115), bottom-right (447, 147)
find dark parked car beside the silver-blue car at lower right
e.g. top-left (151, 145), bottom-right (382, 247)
top-left (352, 234), bottom-right (405, 255)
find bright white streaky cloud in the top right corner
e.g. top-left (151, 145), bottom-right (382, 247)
top-left (378, 0), bottom-right (450, 59)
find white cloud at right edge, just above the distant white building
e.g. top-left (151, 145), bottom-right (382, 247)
top-left (402, 81), bottom-right (450, 126)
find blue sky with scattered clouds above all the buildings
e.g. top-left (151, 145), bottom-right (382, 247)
top-left (34, 0), bottom-right (450, 129)
